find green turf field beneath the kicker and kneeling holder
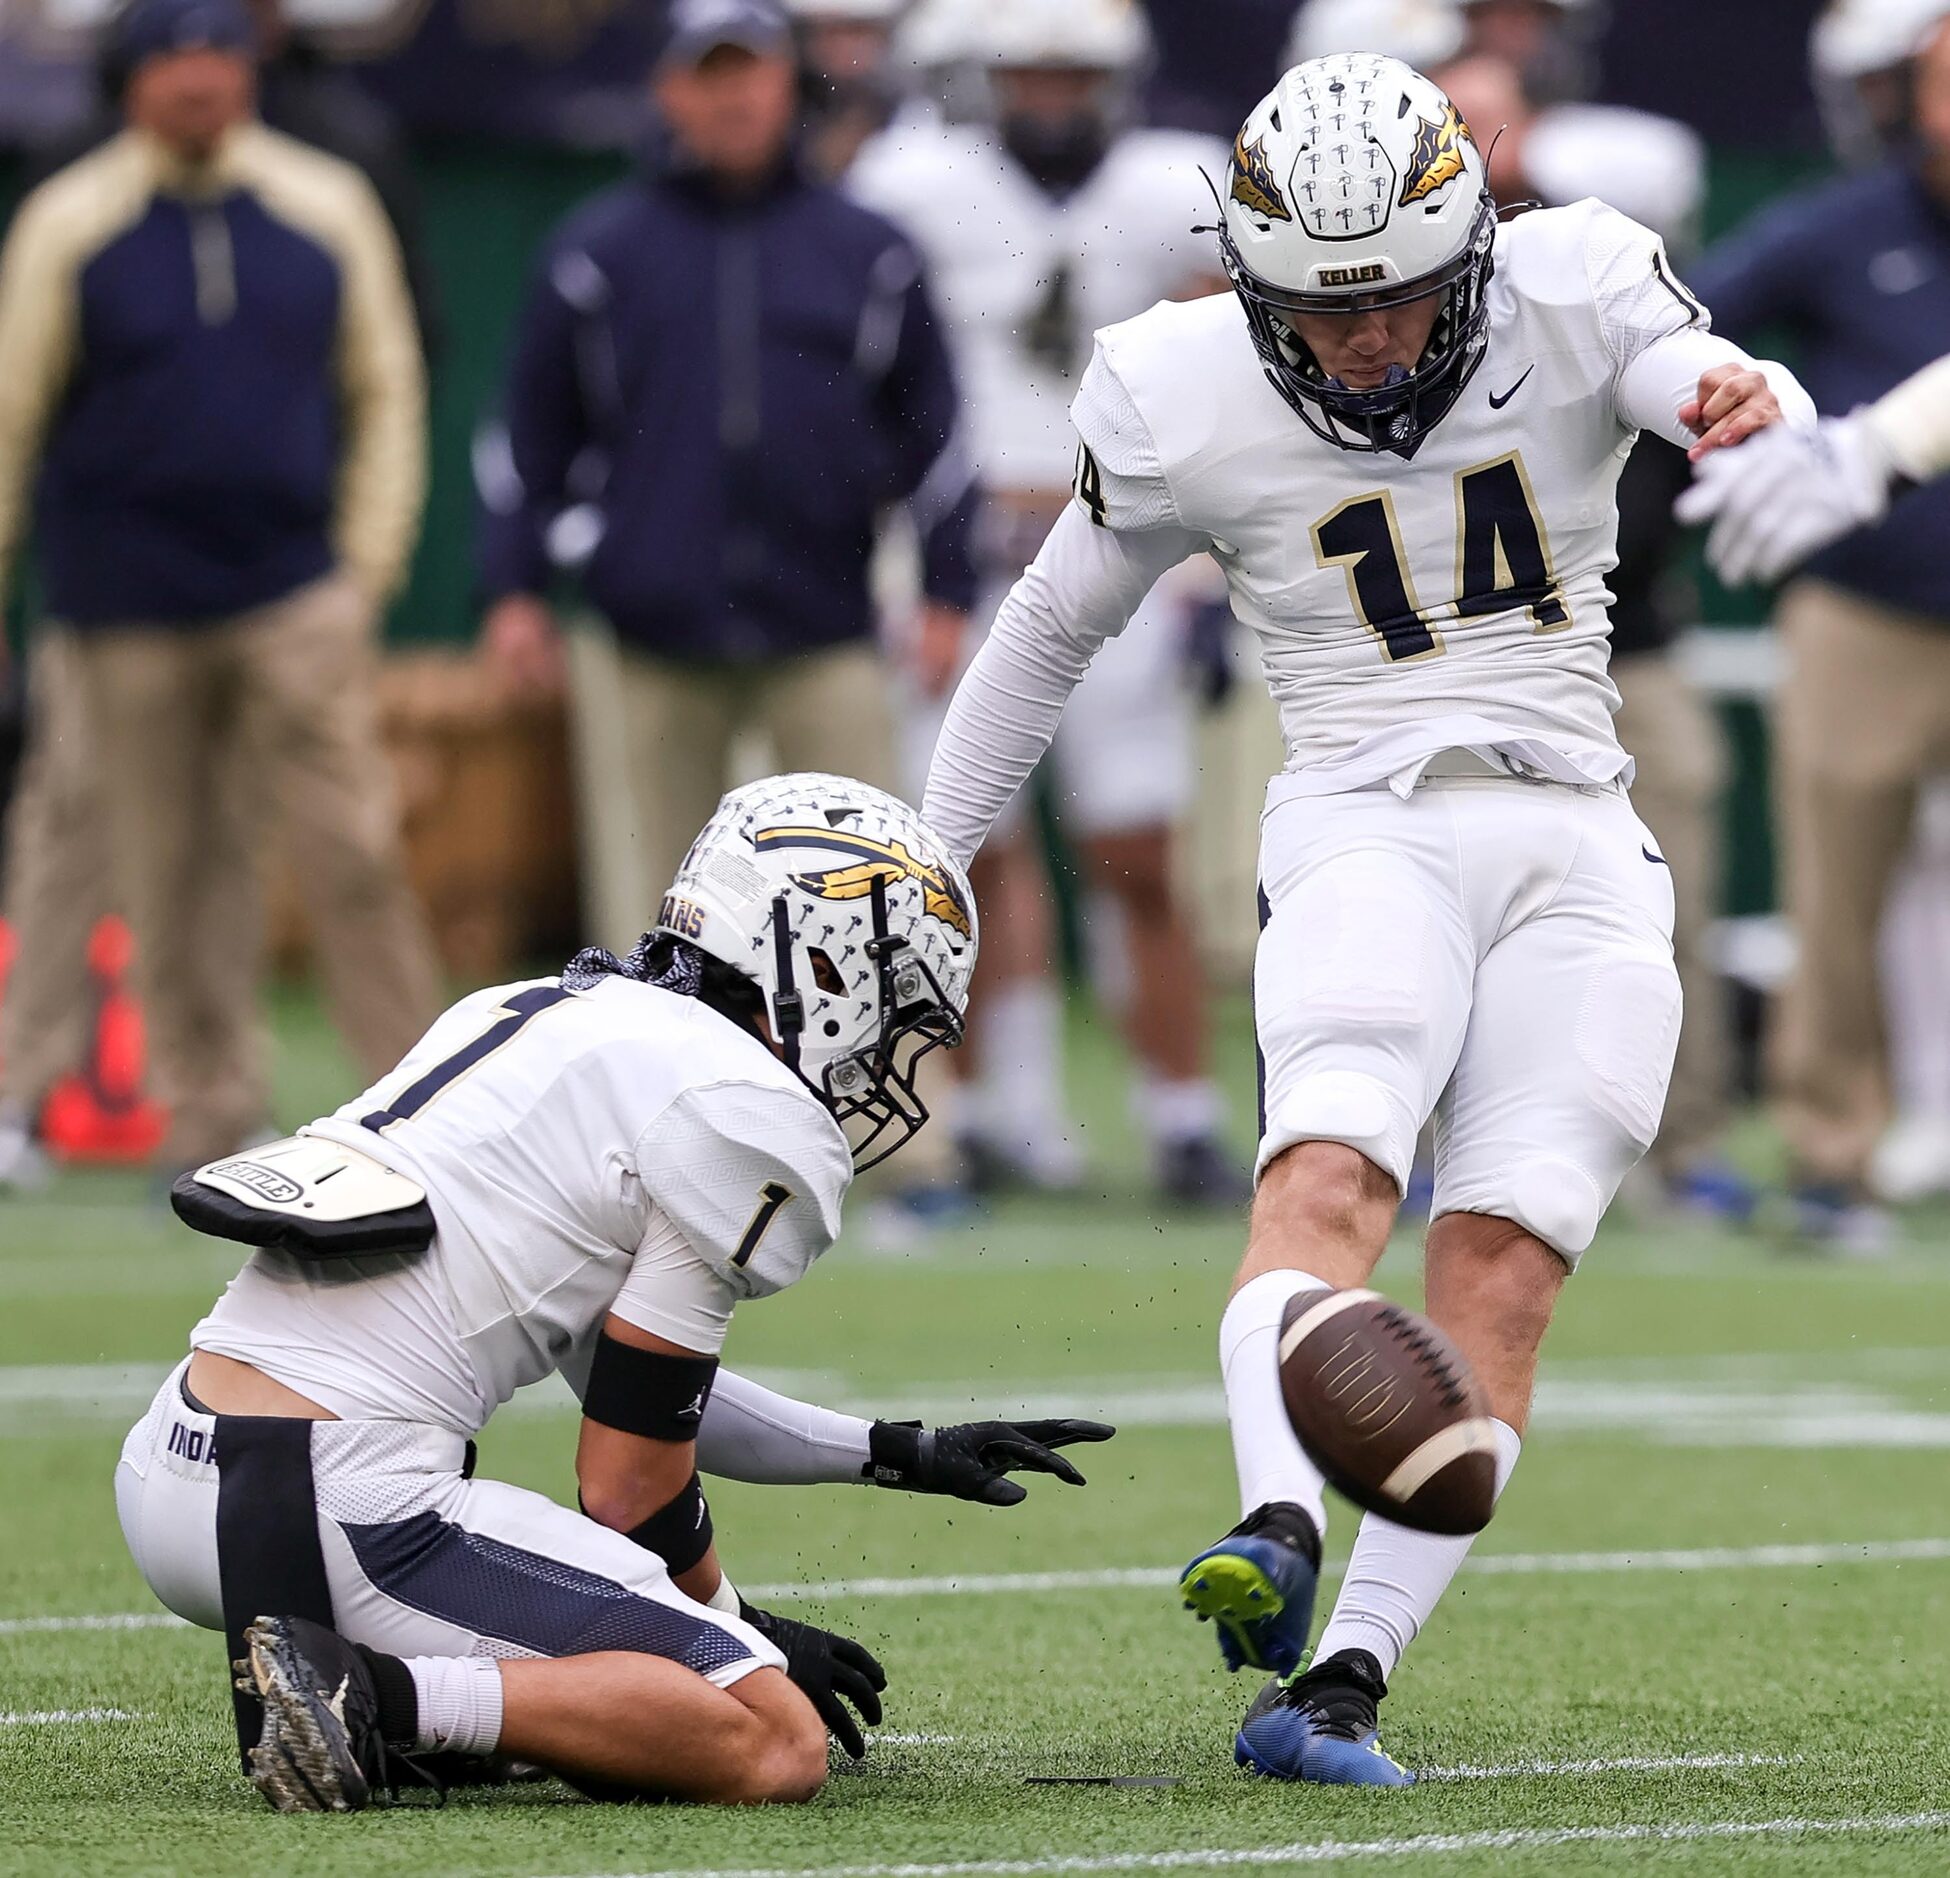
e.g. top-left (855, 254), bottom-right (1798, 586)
top-left (0, 982), bottom-right (1950, 1878)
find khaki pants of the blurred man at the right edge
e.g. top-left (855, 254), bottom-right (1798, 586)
top-left (1773, 579), bottom-right (1950, 1182)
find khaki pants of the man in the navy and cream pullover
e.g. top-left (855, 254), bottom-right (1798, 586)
top-left (74, 579), bottom-right (439, 1166)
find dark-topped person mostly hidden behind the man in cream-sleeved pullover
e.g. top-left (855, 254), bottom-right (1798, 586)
top-left (0, 0), bottom-right (439, 1192)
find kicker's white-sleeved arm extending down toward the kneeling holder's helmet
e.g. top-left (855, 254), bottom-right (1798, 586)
top-left (920, 347), bottom-right (1211, 866)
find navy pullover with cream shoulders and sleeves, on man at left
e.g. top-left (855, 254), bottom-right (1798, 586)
top-left (0, 125), bottom-right (425, 628)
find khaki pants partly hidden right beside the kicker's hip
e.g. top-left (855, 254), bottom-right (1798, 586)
top-left (1611, 651), bottom-right (1732, 1174)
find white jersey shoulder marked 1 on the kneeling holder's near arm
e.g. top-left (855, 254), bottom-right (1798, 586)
top-left (636, 1082), bottom-right (852, 1297)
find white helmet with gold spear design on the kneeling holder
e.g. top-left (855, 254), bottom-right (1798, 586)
top-left (657, 774), bottom-right (979, 1168)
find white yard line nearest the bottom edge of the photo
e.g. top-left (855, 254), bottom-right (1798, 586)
top-left (530, 1812), bottom-right (1950, 1878)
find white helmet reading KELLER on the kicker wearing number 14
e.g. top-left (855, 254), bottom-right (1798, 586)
top-left (1219, 53), bottom-right (1496, 456)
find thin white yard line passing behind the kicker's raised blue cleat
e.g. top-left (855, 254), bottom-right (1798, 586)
top-left (15, 1539), bottom-right (1950, 1636)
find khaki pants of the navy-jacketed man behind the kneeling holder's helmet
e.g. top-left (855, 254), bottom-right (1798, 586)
top-left (569, 624), bottom-right (899, 950)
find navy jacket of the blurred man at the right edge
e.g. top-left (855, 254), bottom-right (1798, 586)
top-left (1687, 160), bottom-right (1950, 624)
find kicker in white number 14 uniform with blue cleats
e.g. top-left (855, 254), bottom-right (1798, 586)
top-left (924, 55), bottom-right (1814, 1784)
